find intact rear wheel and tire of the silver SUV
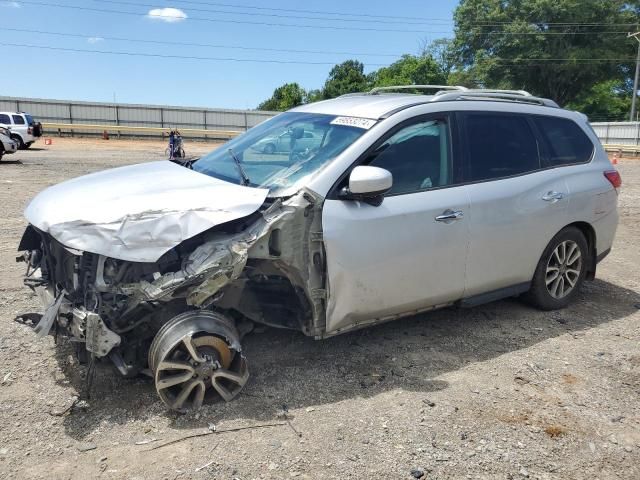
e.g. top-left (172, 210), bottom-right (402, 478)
top-left (523, 227), bottom-right (590, 310)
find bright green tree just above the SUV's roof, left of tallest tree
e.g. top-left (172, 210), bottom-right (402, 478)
top-left (369, 54), bottom-right (447, 87)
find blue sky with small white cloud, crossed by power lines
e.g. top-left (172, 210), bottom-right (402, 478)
top-left (0, 0), bottom-right (458, 108)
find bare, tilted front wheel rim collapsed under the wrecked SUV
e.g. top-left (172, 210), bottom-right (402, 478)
top-left (149, 311), bottom-right (249, 411)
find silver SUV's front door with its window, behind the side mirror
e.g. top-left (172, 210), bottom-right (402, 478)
top-left (322, 116), bottom-right (469, 333)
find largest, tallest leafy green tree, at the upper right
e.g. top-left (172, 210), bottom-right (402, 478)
top-left (454, 0), bottom-right (638, 105)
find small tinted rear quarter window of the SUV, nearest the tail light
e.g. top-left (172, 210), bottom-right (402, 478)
top-left (534, 116), bottom-right (593, 167)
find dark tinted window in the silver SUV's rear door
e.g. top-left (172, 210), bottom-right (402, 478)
top-left (462, 112), bottom-right (541, 182)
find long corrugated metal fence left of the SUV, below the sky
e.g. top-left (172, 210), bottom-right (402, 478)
top-left (0, 96), bottom-right (278, 137)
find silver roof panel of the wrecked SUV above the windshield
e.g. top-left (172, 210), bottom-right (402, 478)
top-left (292, 94), bottom-right (433, 120)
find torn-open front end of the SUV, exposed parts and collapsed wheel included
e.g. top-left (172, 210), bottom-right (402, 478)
top-left (18, 190), bottom-right (326, 410)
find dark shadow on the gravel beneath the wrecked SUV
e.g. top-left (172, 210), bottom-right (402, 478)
top-left (47, 280), bottom-right (640, 439)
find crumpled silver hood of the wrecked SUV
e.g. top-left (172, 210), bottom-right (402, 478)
top-left (24, 161), bottom-right (269, 262)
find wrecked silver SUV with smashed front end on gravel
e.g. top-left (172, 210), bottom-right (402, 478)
top-left (19, 86), bottom-right (620, 410)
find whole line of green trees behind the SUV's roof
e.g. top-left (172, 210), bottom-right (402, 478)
top-left (258, 0), bottom-right (640, 120)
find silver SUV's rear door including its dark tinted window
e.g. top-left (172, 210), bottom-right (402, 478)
top-left (459, 112), bottom-right (569, 297)
